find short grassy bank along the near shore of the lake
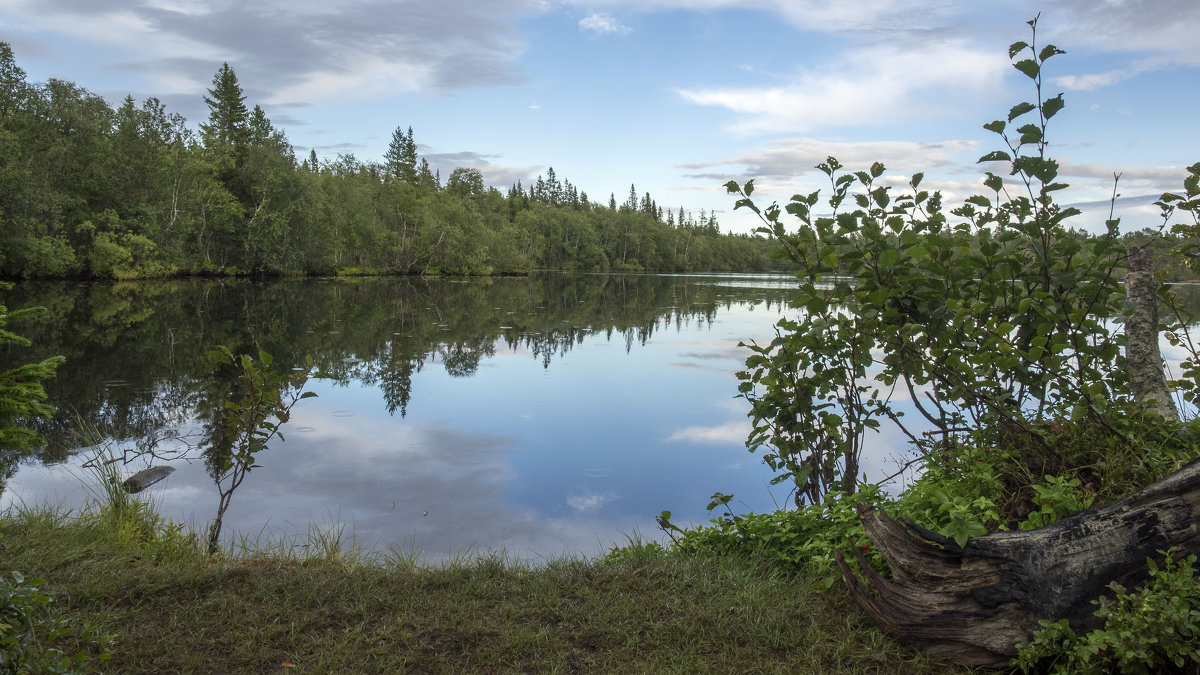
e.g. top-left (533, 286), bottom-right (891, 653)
top-left (0, 497), bottom-right (969, 674)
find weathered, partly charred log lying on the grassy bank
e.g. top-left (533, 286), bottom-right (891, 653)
top-left (835, 460), bottom-right (1200, 667)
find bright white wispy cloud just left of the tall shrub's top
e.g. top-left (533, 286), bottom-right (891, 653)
top-left (677, 41), bottom-right (1009, 132)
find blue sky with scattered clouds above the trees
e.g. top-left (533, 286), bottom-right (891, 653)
top-left (0, 0), bottom-right (1200, 232)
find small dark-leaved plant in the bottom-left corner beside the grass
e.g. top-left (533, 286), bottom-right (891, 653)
top-left (0, 572), bottom-right (113, 675)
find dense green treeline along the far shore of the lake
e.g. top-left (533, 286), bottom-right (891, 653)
top-left (0, 43), bottom-right (786, 279)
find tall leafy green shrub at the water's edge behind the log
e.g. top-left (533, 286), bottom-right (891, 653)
top-left (727, 13), bottom-right (1130, 506)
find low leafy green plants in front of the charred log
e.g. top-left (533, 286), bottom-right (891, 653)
top-left (1014, 551), bottom-right (1200, 675)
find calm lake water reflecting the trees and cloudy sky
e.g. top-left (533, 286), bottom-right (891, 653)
top-left (0, 270), bottom-right (873, 561)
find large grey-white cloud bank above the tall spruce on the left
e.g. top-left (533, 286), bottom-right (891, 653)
top-left (0, 0), bottom-right (541, 103)
